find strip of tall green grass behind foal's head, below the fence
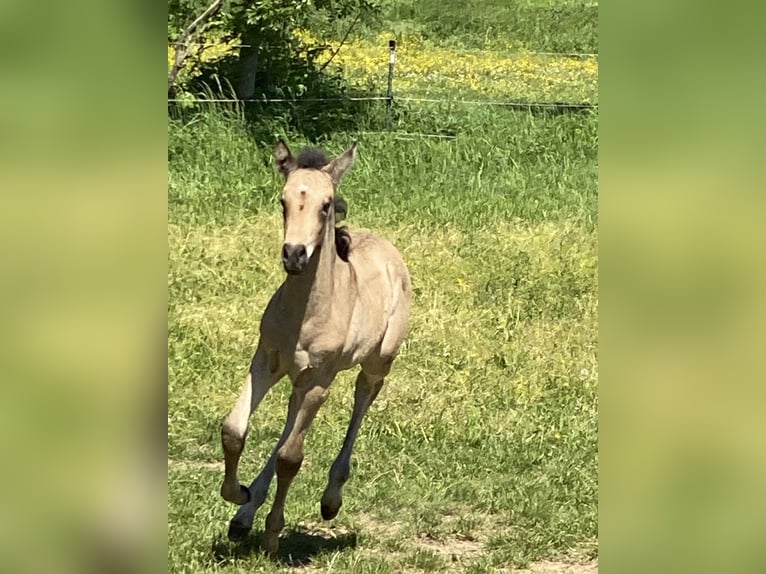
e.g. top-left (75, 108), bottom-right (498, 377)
top-left (168, 105), bottom-right (597, 227)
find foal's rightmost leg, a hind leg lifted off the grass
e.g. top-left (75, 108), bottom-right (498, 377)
top-left (321, 370), bottom-right (383, 520)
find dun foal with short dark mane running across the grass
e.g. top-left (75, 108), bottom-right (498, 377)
top-left (221, 141), bottom-right (412, 555)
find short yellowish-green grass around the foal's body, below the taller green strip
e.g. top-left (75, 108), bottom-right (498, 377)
top-left (169, 213), bottom-right (598, 572)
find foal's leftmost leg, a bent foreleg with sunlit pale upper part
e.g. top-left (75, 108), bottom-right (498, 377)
top-left (221, 345), bottom-right (281, 504)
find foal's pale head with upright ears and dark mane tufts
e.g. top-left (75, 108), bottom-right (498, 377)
top-left (274, 140), bottom-right (356, 274)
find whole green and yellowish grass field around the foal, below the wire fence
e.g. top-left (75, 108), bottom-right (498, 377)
top-left (168, 3), bottom-right (598, 573)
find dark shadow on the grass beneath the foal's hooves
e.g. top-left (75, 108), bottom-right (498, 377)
top-left (212, 526), bottom-right (357, 568)
